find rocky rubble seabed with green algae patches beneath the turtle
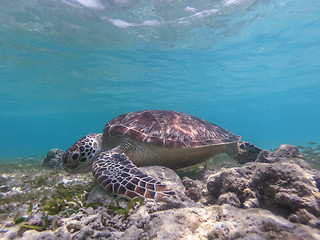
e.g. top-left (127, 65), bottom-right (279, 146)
top-left (0, 145), bottom-right (320, 240)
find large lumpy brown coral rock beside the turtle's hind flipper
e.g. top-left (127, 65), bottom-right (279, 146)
top-left (207, 145), bottom-right (320, 225)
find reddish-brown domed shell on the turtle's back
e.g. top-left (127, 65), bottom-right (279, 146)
top-left (103, 110), bottom-right (241, 148)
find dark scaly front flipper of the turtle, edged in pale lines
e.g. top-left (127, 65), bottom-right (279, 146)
top-left (92, 151), bottom-right (176, 201)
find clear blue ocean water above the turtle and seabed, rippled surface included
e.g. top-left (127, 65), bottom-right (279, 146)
top-left (0, 0), bottom-right (320, 158)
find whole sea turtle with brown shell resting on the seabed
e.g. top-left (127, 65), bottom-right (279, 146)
top-left (63, 110), bottom-right (261, 201)
